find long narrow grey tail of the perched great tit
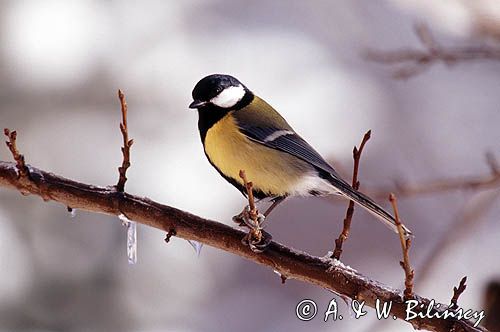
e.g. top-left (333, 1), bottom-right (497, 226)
top-left (327, 175), bottom-right (413, 237)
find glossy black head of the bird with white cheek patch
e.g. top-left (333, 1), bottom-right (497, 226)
top-left (189, 74), bottom-right (253, 110)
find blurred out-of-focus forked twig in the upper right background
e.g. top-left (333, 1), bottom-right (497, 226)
top-left (365, 24), bottom-right (500, 79)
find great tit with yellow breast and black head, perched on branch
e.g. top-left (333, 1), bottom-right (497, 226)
top-left (189, 74), bottom-right (411, 236)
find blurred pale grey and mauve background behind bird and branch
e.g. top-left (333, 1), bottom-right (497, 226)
top-left (0, 0), bottom-right (500, 332)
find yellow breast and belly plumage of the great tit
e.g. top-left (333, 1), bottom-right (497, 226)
top-left (204, 113), bottom-right (309, 196)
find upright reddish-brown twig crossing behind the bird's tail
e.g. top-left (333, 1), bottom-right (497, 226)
top-left (332, 130), bottom-right (372, 259)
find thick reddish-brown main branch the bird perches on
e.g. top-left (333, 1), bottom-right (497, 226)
top-left (0, 162), bottom-right (484, 331)
